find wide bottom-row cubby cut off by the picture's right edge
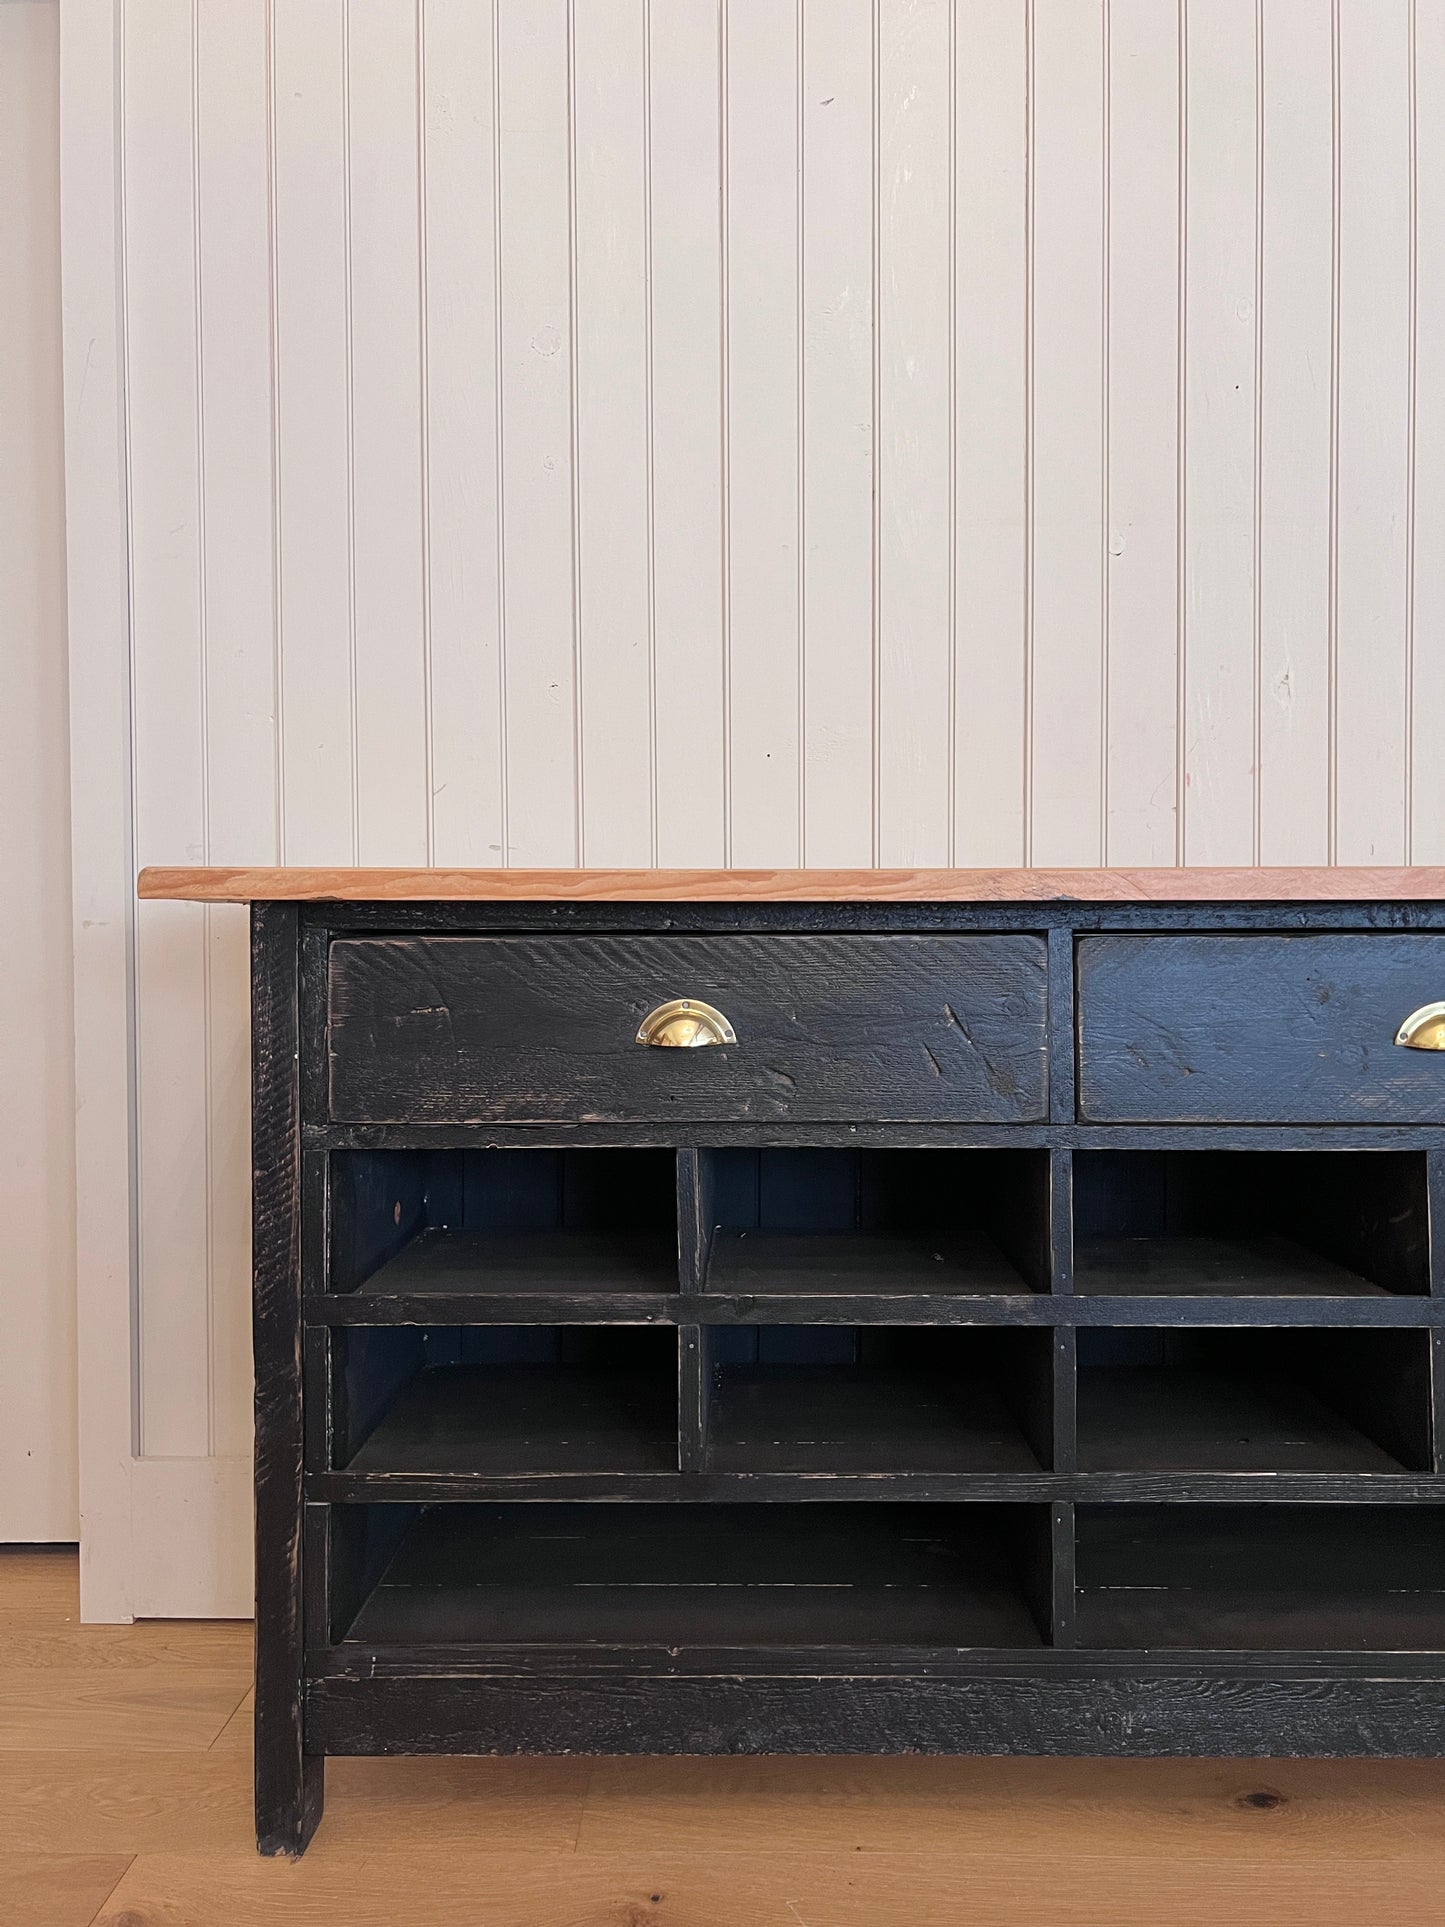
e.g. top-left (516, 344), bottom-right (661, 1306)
top-left (1075, 1505), bottom-right (1445, 1651)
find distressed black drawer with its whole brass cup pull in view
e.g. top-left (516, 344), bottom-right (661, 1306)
top-left (328, 935), bottom-right (1048, 1123)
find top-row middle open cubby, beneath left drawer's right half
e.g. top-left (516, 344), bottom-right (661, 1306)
top-left (697, 1148), bottom-right (1050, 1295)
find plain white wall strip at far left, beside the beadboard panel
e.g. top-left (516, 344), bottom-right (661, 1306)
top-left (0, 0), bottom-right (77, 1544)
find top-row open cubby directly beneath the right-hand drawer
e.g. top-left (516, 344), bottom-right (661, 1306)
top-left (1073, 1150), bottom-right (1430, 1297)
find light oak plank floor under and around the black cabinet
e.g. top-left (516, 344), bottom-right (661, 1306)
top-left (0, 1549), bottom-right (1445, 1927)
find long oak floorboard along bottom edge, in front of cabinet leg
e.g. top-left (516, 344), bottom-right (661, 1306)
top-left (84, 1835), bottom-right (1441, 1927)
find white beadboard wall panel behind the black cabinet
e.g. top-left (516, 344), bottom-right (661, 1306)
top-left (64, 0), bottom-right (1445, 1611)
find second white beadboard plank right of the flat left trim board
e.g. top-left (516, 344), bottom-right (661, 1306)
top-left (195, 0), bottom-right (279, 1455)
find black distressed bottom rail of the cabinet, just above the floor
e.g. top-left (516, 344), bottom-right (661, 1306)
top-left (308, 1655), bottom-right (1445, 1759)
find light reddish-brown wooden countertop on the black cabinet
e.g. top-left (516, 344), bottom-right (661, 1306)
top-left (139, 865), bottom-right (1445, 904)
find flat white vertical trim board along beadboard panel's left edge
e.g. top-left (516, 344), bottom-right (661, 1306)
top-left (60, 0), bottom-right (135, 1621)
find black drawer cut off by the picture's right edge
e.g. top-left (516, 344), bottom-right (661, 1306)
top-left (1077, 933), bottom-right (1445, 1123)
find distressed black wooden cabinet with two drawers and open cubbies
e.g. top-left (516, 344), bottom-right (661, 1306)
top-left (138, 873), bottom-right (1445, 1852)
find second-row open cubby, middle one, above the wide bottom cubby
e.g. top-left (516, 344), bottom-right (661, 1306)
top-left (701, 1324), bottom-right (1054, 1476)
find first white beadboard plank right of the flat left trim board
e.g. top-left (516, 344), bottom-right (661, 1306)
top-left (121, 4), bottom-right (212, 1457)
